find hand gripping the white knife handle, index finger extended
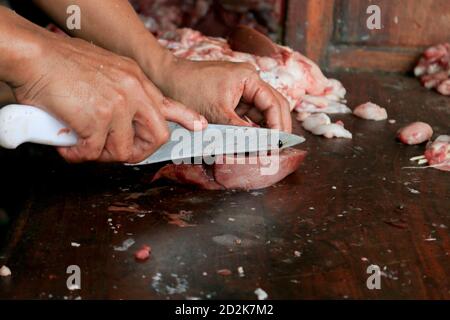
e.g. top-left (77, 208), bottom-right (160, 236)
top-left (13, 33), bottom-right (207, 163)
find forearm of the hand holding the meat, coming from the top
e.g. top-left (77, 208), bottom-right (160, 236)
top-left (34, 0), bottom-right (173, 85)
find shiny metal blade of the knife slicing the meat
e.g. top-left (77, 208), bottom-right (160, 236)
top-left (132, 122), bottom-right (305, 165)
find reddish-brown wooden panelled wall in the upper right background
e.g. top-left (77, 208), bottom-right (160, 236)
top-left (285, 0), bottom-right (450, 72)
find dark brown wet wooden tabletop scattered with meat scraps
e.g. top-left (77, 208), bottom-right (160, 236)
top-left (0, 74), bottom-right (450, 299)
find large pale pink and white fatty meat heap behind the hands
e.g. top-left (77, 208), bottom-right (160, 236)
top-left (159, 29), bottom-right (351, 113)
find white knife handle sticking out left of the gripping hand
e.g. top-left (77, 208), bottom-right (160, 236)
top-left (0, 104), bottom-right (78, 149)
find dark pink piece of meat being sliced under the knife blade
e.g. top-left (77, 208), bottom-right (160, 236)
top-left (152, 148), bottom-right (306, 190)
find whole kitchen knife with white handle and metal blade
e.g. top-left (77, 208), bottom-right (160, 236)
top-left (0, 104), bottom-right (305, 165)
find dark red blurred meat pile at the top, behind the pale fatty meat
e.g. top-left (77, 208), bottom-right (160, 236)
top-left (130, 0), bottom-right (284, 40)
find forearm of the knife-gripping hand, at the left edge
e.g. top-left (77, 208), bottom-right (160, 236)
top-left (0, 6), bottom-right (45, 87)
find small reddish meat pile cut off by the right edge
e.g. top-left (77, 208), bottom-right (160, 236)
top-left (414, 43), bottom-right (450, 96)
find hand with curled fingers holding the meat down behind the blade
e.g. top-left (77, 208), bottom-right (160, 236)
top-left (153, 59), bottom-right (292, 132)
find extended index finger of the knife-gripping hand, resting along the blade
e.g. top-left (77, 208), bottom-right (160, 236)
top-left (161, 97), bottom-right (208, 131)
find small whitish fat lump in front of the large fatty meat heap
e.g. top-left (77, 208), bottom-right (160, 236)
top-left (302, 113), bottom-right (352, 139)
